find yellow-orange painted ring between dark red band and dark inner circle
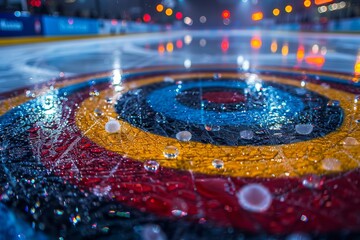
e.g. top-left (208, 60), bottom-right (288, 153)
top-left (76, 73), bottom-right (360, 177)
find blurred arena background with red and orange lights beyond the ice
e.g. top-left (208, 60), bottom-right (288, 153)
top-left (0, 0), bottom-right (360, 36)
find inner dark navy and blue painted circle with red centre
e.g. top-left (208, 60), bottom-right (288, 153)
top-left (116, 78), bottom-right (343, 146)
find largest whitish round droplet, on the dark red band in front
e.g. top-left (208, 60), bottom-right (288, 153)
top-left (236, 183), bottom-right (272, 212)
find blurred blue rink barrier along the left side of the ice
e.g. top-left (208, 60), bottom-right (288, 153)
top-left (0, 12), bottom-right (164, 37)
